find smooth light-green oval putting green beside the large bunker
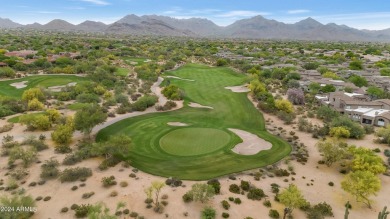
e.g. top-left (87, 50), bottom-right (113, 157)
top-left (160, 128), bottom-right (230, 156)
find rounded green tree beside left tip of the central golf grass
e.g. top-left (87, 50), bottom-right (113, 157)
top-left (74, 104), bottom-right (107, 137)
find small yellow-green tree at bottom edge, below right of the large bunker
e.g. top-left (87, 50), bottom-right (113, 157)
top-left (278, 184), bottom-right (308, 215)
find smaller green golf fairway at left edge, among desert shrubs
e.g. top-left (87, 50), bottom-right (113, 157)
top-left (0, 75), bottom-right (88, 98)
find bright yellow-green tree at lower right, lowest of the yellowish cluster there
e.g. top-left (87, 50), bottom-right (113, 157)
top-left (341, 170), bottom-right (381, 208)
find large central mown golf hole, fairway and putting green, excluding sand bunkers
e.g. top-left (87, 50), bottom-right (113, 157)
top-left (97, 64), bottom-right (291, 180)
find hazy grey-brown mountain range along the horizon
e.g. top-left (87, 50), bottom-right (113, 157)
top-left (0, 15), bottom-right (390, 42)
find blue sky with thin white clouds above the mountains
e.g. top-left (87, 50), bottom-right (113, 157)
top-left (0, 0), bottom-right (390, 30)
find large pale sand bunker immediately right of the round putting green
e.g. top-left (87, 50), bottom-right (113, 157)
top-left (229, 129), bottom-right (272, 155)
